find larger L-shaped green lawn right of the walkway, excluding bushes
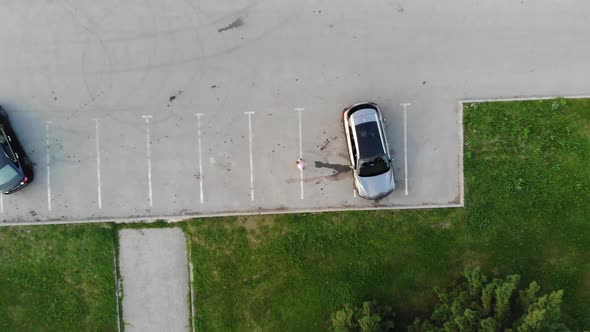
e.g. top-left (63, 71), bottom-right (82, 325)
top-left (184, 100), bottom-right (590, 331)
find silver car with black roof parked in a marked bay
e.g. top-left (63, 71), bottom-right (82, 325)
top-left (342, 102), bottom-right (395, 199)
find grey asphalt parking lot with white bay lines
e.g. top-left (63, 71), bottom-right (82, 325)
top-left (0, 0), bottom-right (590, 224)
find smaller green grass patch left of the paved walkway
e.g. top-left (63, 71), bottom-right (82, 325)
top-left (0, 224), bottom-right (117, 331)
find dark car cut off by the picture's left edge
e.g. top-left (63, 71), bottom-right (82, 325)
top-left (0, 106), bottom-right (33, 194)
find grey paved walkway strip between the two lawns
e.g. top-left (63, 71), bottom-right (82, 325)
top-left (119, 228), bottom-right (190, 331)
